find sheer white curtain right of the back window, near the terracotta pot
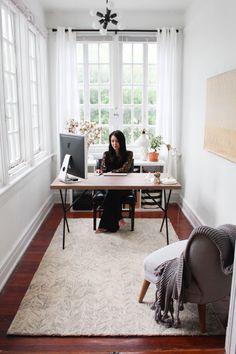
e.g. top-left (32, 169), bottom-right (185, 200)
top-left (157, 28), bottom-right (182, 177)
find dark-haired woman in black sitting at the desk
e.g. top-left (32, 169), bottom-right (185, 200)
top-left (96, 130), bottom-right (133, 233)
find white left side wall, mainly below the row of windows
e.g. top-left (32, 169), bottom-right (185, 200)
top-left (0, 1), bottom-right (55, 290)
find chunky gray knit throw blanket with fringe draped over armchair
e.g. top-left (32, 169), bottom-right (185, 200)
top-left (152, 224), bottom-right (236, 327)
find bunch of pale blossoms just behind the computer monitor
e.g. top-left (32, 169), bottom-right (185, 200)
top-left (66, 119), bottom-right (102, 145)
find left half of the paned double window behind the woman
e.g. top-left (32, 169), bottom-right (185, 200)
top-left (77, 42), bottom-right (111, 144)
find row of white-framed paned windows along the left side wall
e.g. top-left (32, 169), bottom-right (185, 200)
top-left (0, 0), bottom-right (48, 185)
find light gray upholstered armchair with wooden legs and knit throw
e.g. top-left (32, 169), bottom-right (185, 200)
top-left (138, 224), bottom-right (236, 333)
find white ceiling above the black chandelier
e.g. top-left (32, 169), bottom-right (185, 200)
top-left (38, 0), bottom-right (194, 12)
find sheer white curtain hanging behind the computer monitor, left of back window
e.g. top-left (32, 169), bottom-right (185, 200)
top-left (49, 27), bottom-right (79, 162)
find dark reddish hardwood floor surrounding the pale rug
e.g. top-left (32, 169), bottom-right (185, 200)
top-left (0, 205), bottom-right (225, 354)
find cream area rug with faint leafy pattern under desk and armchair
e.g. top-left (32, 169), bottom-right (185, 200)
top-left (8, 219), bottom-right (224, 336)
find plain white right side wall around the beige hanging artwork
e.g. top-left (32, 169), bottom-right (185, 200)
top-left (181, 0), bottom-right (236, 226)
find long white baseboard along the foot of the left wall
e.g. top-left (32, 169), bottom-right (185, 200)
top-left (0, 194), bottom-right (54, 291)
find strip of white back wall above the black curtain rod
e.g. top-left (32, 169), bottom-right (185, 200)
top-left (46, 7), bottom-right (184, 29)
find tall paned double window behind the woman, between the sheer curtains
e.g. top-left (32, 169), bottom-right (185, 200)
top-left (77, 36), bottom-right (158, 144)
